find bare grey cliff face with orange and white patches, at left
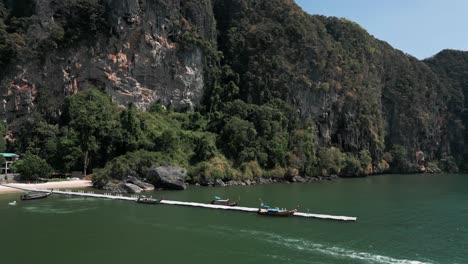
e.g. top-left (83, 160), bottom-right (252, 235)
top-left (0, 0), bottom-right (215, 122)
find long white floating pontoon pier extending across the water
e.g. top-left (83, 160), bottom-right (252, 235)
top-left (0, 184), bottom-right (357, 221)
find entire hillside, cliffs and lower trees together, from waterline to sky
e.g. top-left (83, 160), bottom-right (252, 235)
top-left (0, 0), bottom-right (468, 184)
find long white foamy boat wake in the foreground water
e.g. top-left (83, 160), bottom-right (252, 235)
top-left (210, 227), bottom-right (433, 264)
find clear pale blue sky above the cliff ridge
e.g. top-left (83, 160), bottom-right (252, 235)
top-left (296, 0), bottom-right (468, 59)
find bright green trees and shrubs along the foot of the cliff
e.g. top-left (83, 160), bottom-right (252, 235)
top-left (10, 89), bottom-right (372, 185)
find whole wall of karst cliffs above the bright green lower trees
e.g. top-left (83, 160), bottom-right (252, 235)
top-left (0, 0), bottom-right (468, 165)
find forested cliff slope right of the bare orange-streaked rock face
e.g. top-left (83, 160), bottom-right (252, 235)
top-left (215, 0), bottom-right (461, 161)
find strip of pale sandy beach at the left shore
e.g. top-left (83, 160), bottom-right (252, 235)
top-left (0, 180), bottom-right (93, 194)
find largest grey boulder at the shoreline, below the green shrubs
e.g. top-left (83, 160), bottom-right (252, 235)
top-left (148, 166), bottom-right (187, 190)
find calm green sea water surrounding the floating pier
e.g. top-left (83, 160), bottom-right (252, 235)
top-left (0, 174), bottom-right (468, 264)
